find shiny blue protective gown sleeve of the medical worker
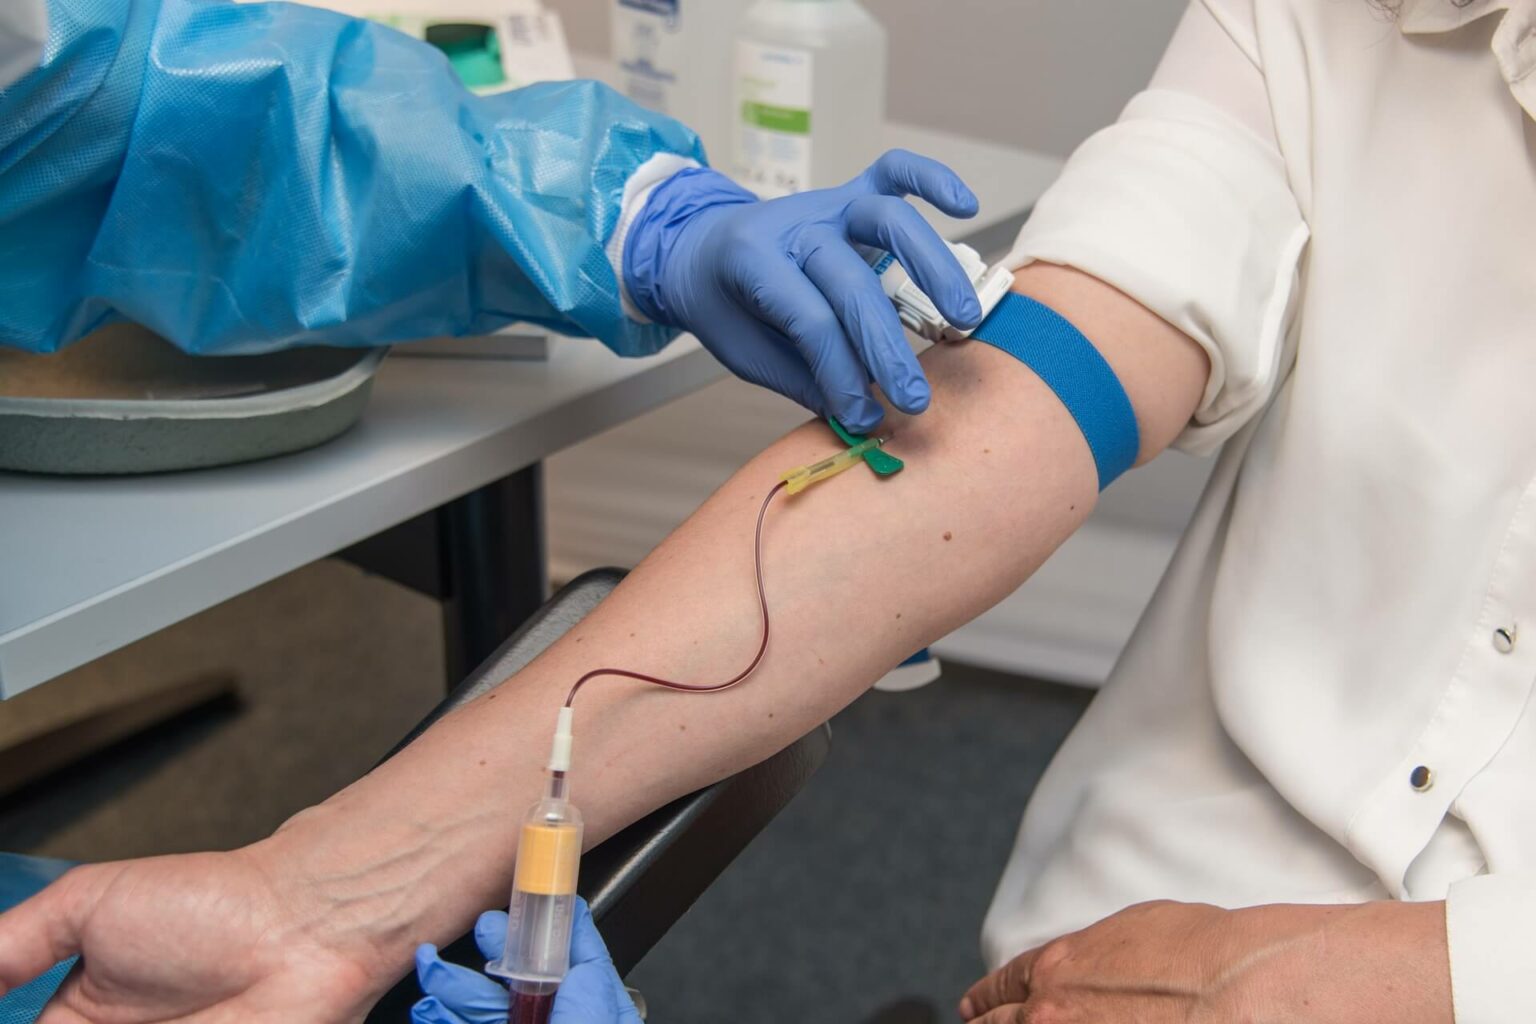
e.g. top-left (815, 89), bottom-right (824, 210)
top-left (0, 0), bottom-right (703, 355)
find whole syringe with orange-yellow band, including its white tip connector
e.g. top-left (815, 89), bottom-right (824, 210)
top-left (485, 708), bottom-right (582, 1024)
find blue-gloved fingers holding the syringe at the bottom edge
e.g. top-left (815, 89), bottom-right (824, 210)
top-left (410, 900), bottom-right (641, 1024)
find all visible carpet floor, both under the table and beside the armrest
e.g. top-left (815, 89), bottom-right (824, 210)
top-left (0, 562), bottom-right (1087, 1024)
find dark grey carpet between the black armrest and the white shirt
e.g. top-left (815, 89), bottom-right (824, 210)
top-left (630, 665), bottom-right (1087, 1024)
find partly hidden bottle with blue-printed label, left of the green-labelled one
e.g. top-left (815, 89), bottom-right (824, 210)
top-left (611, 0), bottom-right (751, 164)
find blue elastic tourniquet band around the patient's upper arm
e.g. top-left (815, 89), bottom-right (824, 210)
top-left (972, 292), bottom-right (1141, 490)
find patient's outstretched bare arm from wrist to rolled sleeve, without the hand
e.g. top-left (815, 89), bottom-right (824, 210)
top-left (254, 267), bottom-right (1206, 972)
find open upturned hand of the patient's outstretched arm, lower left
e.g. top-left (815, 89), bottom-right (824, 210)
top-left (0, 851), bottom-right (380, 1024)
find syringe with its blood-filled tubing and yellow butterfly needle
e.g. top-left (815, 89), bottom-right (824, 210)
top-left (485, 438), bottom-right (900, 1024)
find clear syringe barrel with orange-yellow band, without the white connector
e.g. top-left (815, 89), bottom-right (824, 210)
top-left (485, 798), bottom-right (582, 992)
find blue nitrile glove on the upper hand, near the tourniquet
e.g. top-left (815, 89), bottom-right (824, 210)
top-left (624, 149), bottom-right (982, 433)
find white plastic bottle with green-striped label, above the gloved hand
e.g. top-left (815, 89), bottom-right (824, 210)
top-left (731, 0), bottom-right (886, 198)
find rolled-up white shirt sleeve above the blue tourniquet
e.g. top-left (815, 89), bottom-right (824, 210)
top-left (1009, 0), bottom-right (1307, 453)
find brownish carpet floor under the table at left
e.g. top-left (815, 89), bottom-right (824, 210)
top-left (0, 562), bottom-right (444, 860)
